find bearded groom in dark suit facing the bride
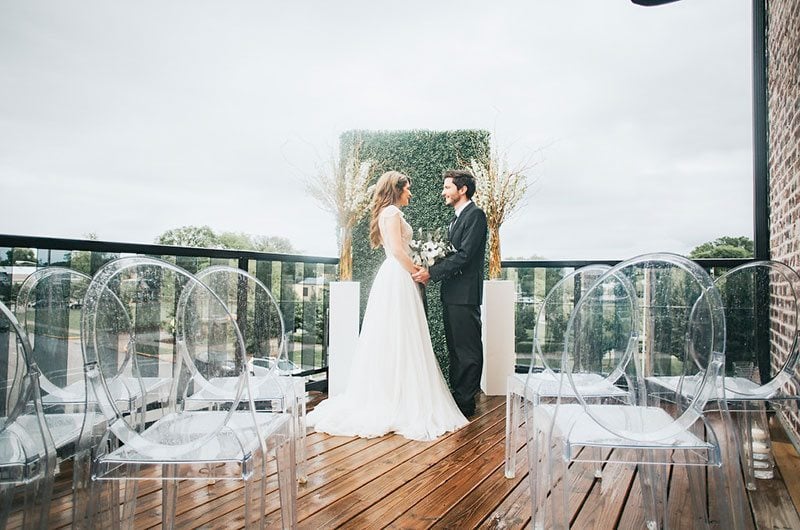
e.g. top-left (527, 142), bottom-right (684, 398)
top-left (414, 170), bottom-right (486, 417)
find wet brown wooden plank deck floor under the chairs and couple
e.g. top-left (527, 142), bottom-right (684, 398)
top-left (12, 396), bottom-right (800, 529)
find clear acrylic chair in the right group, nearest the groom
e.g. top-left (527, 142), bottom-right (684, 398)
top-left (505, 265), bottom-right (631, 478)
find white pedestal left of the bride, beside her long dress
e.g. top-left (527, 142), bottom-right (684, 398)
top-left (328, 282), bottom-right (361, 397)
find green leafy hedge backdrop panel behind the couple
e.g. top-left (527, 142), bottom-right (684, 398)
top-left (339, 130), bottom-right (489, 380)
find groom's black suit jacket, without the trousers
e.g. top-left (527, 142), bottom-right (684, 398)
top-left (429, 202), bottom-right (487, 305)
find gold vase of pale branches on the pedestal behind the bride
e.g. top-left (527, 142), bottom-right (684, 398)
top-left (306, 139), bottom-right (376, 281)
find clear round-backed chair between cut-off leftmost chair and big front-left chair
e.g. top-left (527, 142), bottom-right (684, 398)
top-left (17, 267), bottom-right (170, 526)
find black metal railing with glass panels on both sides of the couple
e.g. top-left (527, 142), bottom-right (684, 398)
top-left (0, 234), bottom-right (751, 386)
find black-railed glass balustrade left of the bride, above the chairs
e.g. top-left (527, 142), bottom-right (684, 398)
top-left (0, 235), bottom-right (339, 388)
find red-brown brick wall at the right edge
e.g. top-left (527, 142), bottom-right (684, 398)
top-left (767, 0), bottom-right (800, 434)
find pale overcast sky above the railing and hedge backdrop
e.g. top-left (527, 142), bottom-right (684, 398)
top-left (0, 0), bottom-right (752, 259)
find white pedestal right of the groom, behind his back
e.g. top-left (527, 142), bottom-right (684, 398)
top-left (481, 280), bottom-right (516, 396)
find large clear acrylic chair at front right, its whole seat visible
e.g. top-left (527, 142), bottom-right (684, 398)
top-left (526, 254), bottom-right (744, 528)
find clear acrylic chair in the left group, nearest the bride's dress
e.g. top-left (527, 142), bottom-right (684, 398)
top-left (184, 265), bottom-right (307, 483)
